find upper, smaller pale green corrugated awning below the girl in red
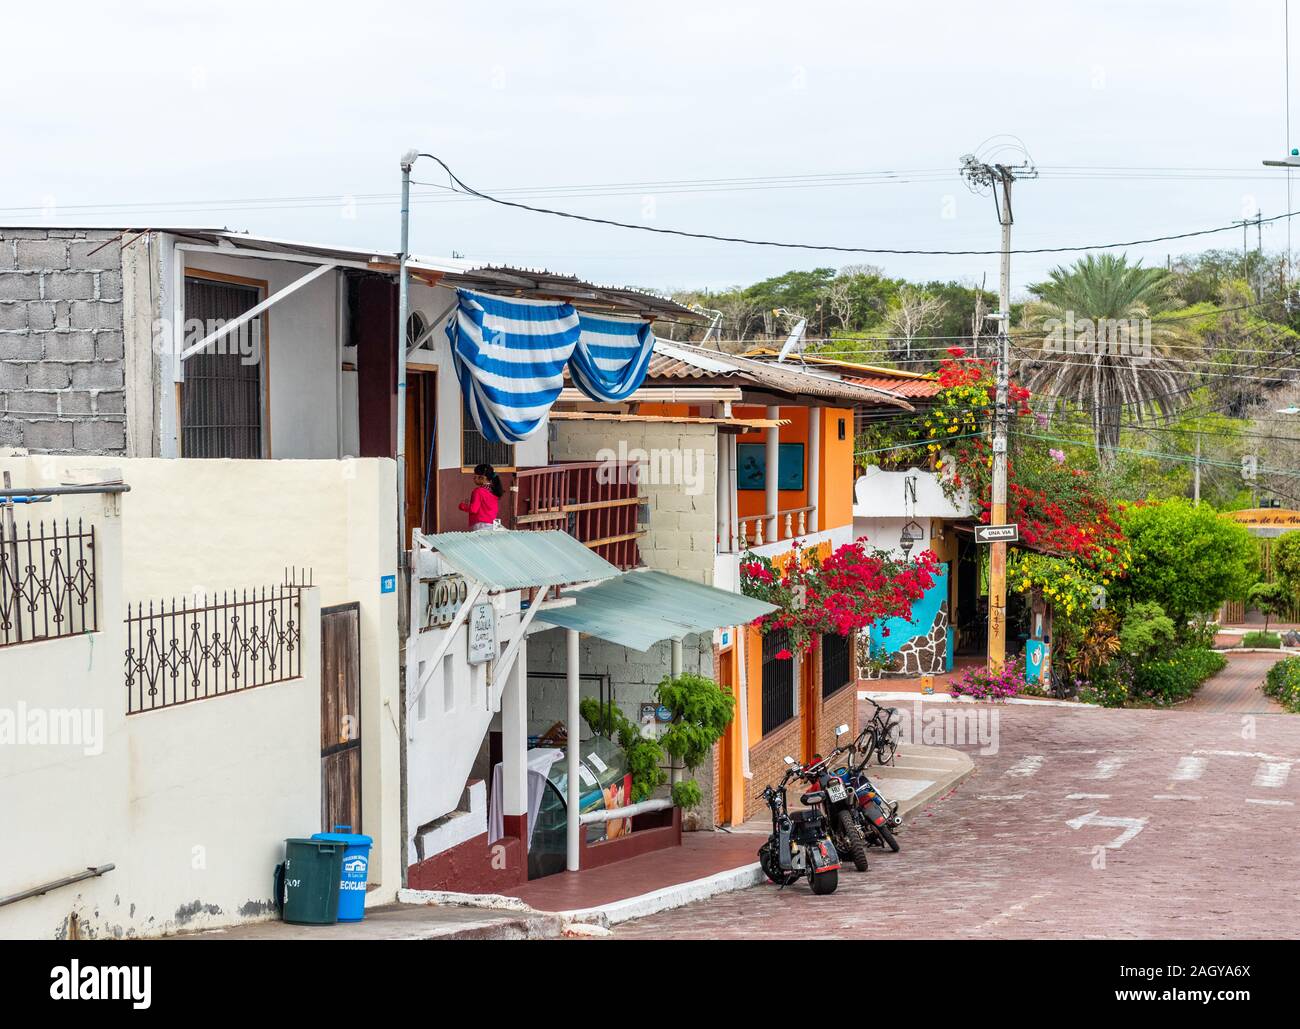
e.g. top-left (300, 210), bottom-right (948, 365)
top-left (425, 529), bottom-right (619, 590)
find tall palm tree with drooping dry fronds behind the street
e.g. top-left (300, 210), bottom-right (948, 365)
top-left (1019, 253), bottom-right (1195, 468)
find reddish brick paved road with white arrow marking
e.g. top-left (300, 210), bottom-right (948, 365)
top-left (615, 704), bottom-right (1300, 938)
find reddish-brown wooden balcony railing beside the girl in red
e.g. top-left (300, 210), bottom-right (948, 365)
top-left (515, 461), bottom-right (644, 569)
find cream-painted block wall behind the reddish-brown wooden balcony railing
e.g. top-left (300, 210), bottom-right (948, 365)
top-left (551, 421), bottom-right (718, 586)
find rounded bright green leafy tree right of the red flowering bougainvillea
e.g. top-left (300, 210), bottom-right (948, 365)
top-left (1113, 498), bottom-right (1255, 634)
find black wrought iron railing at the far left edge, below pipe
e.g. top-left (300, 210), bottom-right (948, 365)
top-left (0, 516), bottom-right (99, 647)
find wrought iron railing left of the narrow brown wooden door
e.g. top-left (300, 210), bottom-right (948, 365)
top-left (125, 574), bottom-right (307, 715)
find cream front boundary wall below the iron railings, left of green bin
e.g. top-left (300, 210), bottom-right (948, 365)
top-left (0, 483), bottom-right (320, 938)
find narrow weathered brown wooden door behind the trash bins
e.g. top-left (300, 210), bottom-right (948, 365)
top-left (321, 603), bottom-right (361, 833)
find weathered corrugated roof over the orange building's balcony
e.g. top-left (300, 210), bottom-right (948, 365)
top-left (646, 339), bottom-right (913, 411)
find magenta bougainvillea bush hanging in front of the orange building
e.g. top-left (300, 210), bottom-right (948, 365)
top-left (740, 537), bottom-right (939, 659)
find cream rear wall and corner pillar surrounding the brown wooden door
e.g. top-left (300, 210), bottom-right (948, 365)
top-left (0, 456), bottom-right (402, 903)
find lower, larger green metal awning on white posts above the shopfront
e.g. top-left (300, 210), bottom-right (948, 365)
top-left (537, 572), bottom-right (776, 651)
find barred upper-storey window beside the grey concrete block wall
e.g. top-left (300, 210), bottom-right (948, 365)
top-left (181, 277), bottom-right (265, 457)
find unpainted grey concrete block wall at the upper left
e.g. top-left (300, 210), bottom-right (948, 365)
top-left (0, 229), bottom-right (126, 455)
